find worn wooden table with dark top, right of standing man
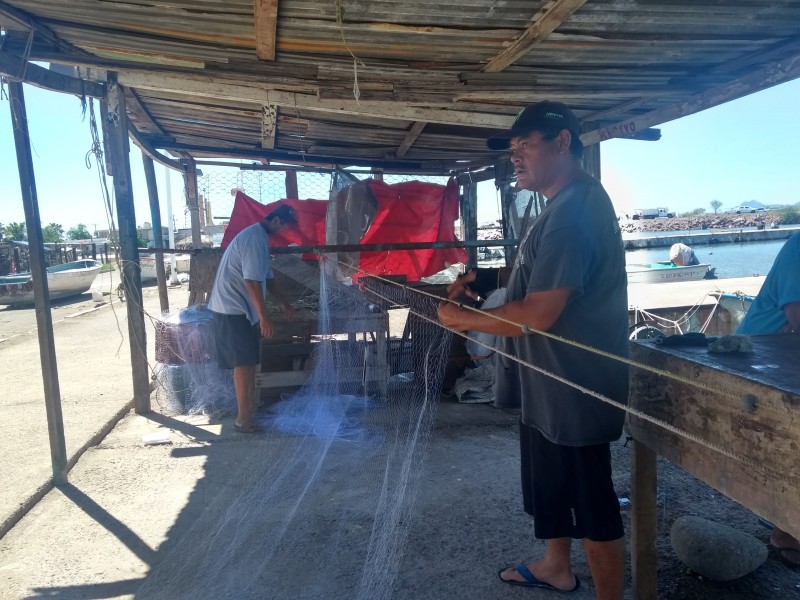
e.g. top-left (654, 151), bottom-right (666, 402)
top-left (627, 335), bottom-right (800, 600)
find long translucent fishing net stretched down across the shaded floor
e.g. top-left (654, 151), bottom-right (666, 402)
top-left (137, 260), bottom-right (451, 600)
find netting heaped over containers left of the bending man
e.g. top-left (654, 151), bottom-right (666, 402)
top-left (153, 304), bottom-right (236, 416)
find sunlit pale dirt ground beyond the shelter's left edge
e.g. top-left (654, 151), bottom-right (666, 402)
top-left (0, 273), bottom-right (188, 524)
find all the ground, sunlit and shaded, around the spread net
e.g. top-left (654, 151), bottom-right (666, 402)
top-left (0, 274), bottom-right (800, 600)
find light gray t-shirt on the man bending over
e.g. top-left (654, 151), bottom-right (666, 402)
top-left (208, 223), bottom-right (272, 325)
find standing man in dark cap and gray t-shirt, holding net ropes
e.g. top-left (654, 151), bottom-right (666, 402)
top-left (439, 102), bottom-right (630, 600)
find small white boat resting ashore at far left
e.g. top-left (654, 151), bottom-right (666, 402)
top-left (0, 259), bottom-right (103, 304)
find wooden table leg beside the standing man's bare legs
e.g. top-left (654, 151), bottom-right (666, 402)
top-left (631, 440), bottom-right (658, 600)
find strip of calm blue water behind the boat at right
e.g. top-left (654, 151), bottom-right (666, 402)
top-left (625, 239), bottom-right (786, 279)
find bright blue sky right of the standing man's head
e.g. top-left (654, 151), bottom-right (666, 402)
top-left (600, 80), bottom-right (800, 212)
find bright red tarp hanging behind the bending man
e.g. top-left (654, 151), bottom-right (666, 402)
top-left (222, 179), bottom-right (467, 281)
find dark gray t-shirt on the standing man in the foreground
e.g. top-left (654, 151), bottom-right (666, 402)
top-left (497, 179), bottom-right (630, 446)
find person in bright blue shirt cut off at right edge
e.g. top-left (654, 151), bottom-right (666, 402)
top-left (736, 232), bottom-right (800, 566)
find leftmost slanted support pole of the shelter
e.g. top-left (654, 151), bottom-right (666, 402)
top-left (7, 81), bottom-right (67, 485)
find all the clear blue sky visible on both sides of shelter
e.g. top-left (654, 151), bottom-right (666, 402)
top-left (0, 81), bottom-right (800, 231)
